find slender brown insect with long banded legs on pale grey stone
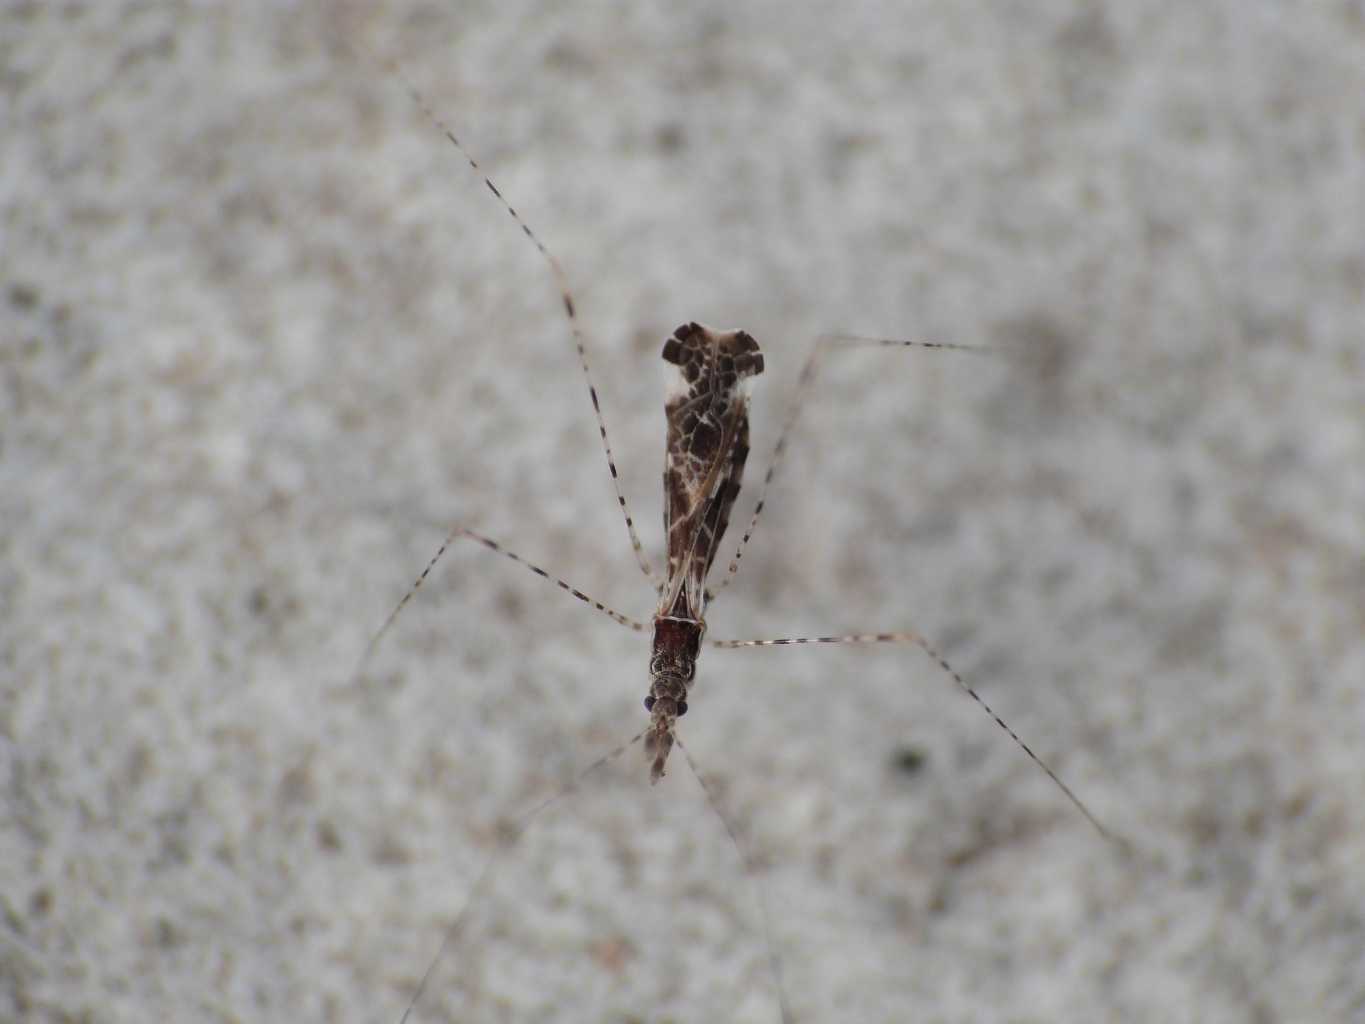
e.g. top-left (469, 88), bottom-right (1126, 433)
top-left (355, 40), bottom-right (1121, 1023)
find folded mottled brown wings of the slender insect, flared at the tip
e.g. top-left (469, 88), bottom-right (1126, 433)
top-left (659, 324), bottom-right (763, 620)
